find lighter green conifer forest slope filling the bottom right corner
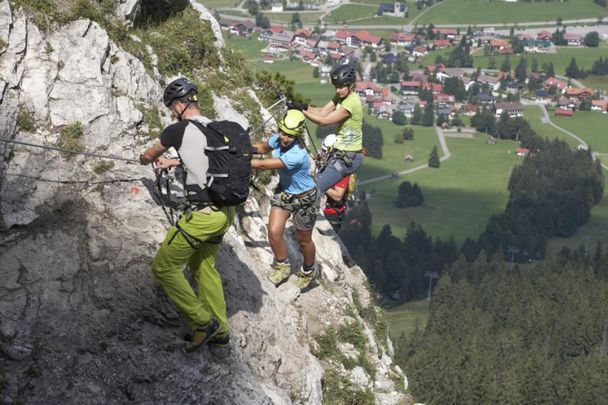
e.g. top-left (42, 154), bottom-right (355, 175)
top-left (395, 251), bottom-right (608, 404)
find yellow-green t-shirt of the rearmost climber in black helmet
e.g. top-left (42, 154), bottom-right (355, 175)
top-left (335, 92), bottom-right (363, 152)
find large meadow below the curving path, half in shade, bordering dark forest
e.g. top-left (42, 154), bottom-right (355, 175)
top-left (362, 135), bottom-right (520, 243)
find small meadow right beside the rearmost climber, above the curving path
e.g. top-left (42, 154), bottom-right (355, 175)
top-left (359, 120), bottom-right (441, 180)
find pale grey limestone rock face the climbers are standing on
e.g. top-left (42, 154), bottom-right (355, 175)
top-left (0, 0), bottom-right (406, 404)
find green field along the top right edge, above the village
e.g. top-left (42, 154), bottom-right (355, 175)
top-left (412, 0), bottom-right (608, 24)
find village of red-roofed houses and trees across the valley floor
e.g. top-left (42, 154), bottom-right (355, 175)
top-left (219, 9), bottom-right (608, 132)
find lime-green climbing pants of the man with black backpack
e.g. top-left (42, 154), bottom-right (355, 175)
top-left (152, 207), bottom-right (234, 334)
